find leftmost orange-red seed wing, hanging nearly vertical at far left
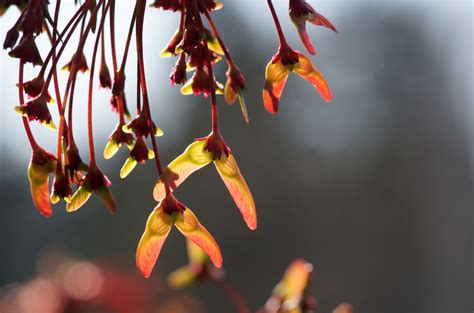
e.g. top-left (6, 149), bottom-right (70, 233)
top-left (28, 163), bottom-right (53, 217)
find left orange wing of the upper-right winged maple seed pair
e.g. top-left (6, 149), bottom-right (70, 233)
top-left (262, 61), bottom-right (290, 114)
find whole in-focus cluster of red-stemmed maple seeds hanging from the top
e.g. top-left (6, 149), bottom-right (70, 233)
top-left (0, 0), bottom-right (336, 277)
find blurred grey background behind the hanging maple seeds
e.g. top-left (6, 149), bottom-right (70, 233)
top-left (0, 0), bottom-right (474, 313)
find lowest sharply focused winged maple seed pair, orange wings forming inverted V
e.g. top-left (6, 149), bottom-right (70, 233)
top-left (136, 194), bottom-right (222, 277)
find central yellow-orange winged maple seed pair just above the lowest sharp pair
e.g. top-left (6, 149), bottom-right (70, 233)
top-left (153, 133), bottom-right (257, 230)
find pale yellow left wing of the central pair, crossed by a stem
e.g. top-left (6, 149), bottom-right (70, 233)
top-left (153, 140), bottom-right (212, 201)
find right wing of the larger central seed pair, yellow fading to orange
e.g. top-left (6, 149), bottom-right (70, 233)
top-left (214, 154), bottom-right (257, 230)
